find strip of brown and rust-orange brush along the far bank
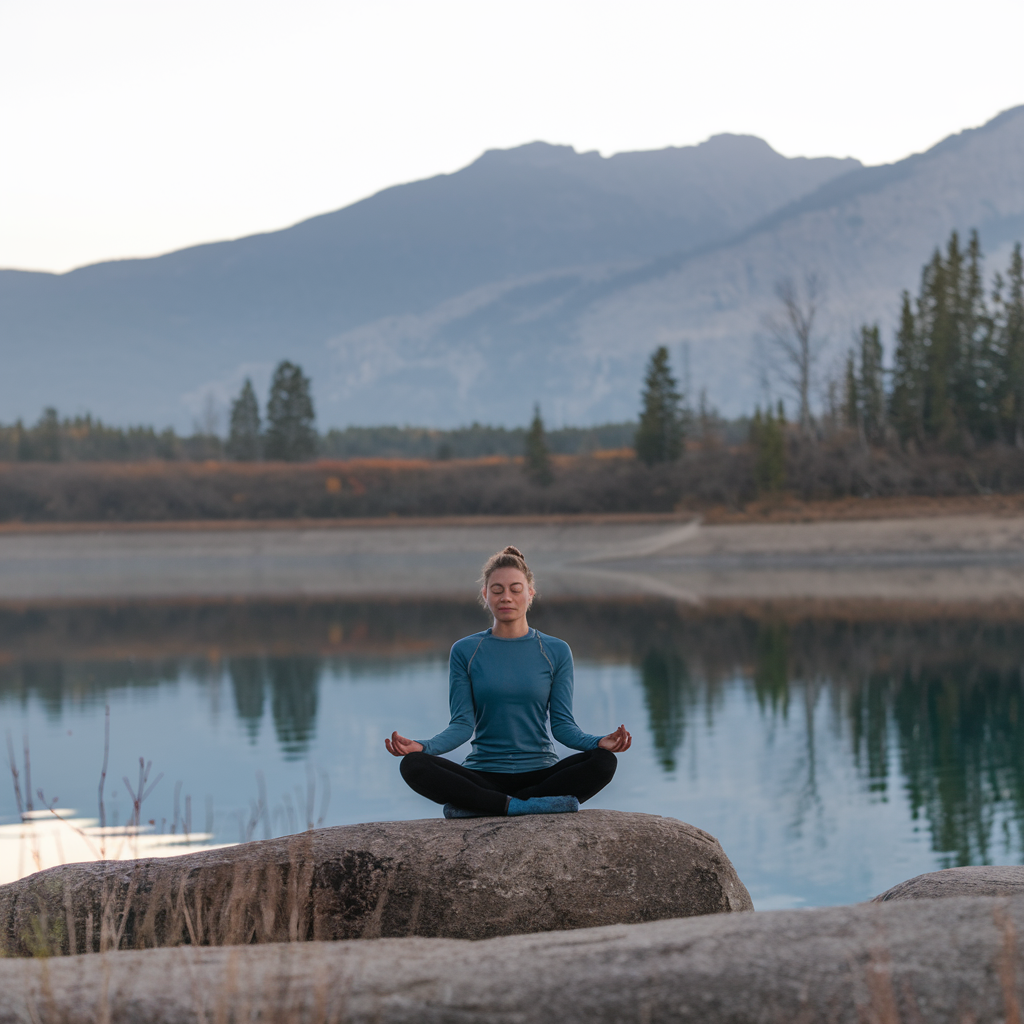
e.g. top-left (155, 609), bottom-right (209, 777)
top-left (0, 436), bottom-right (1024, 525)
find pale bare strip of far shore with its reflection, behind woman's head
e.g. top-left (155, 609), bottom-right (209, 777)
top-left (0, 503), bottom-right (1024, 605)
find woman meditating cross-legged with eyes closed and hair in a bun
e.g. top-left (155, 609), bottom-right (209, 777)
top-left (384, 545), bottom-right (633, 818)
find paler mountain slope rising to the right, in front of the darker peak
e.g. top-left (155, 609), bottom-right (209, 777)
top-left (331, 108), bottom-right (1024, 423)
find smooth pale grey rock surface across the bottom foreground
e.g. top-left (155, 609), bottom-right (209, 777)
top-left (0, 897), bottom-right (1024, 1024)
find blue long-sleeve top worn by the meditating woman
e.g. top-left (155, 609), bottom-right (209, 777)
top-left (421, 629), bottom-right (601, 772)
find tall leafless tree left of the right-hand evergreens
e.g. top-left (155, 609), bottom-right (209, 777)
top-left (762, 273), bottom-right (824, 434)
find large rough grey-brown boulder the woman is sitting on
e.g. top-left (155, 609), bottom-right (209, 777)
top-left (0, 810), bottom-right (754, 955)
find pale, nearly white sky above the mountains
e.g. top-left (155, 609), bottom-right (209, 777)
top-left (0, 0), bottom-right (1024, 270)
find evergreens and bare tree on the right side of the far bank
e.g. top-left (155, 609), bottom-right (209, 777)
top-left (634, 231), bottom-right (1024, 493)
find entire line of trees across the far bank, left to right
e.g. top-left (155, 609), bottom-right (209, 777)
top-left (6, 231), bottom-right (1024, 492)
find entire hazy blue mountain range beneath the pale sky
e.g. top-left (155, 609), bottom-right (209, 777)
top-left (8, 108), bottom-right (1024, 426)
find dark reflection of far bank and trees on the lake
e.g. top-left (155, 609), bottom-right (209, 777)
top-left (0, 600), bottom-right (1024, 880)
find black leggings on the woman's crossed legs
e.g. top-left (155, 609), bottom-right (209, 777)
top-left (401, 746), bottom-right (617, 816)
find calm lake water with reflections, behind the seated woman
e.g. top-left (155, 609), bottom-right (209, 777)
top-left (0, 601), bottom-right (1024, 909)
